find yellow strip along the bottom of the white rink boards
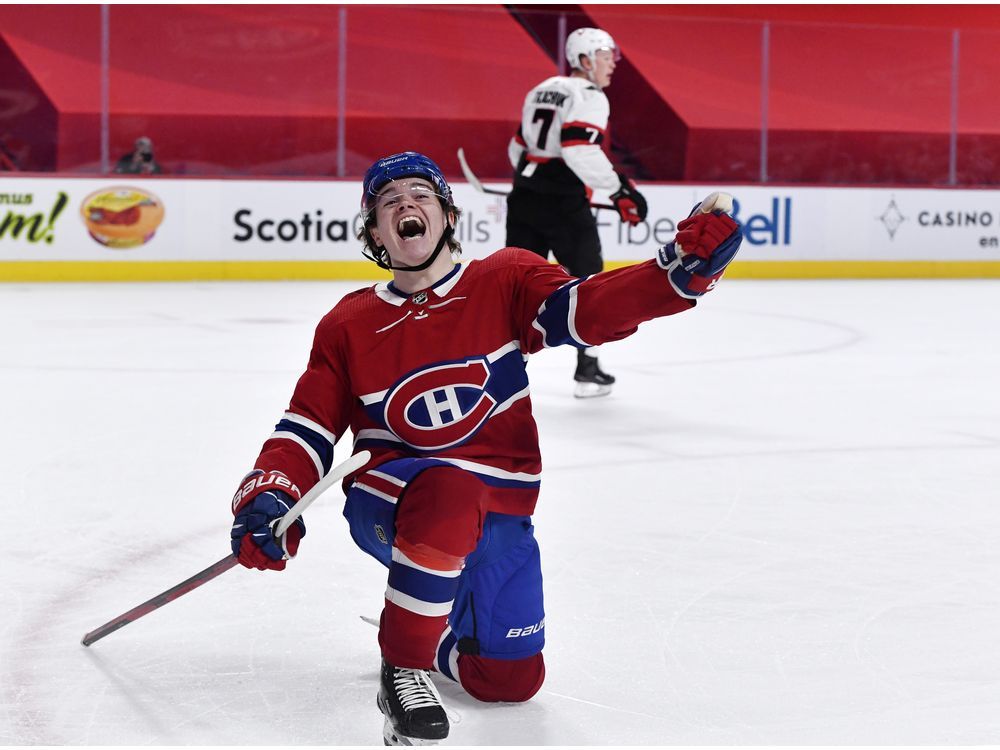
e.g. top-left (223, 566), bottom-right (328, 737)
top-left (0, 260), bottom-right (1000, 282)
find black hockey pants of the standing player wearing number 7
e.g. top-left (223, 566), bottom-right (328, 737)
top-left (507, 188), bottom-right (604, 277)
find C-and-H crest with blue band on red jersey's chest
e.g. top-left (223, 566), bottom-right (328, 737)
top-left (362, 344), bottom-right (528, 451)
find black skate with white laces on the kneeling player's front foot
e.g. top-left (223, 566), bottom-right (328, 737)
top-left (378, 659), bottom-right (448, 746)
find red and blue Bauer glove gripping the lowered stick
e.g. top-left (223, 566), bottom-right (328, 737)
top-left (230, 469), bottom-right (306, 570)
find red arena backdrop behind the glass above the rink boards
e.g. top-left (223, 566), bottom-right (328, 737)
top-left (0, 5), bottom-right (1000, 185)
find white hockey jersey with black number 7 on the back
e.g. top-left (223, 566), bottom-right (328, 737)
top-left (508, 76), bottom-right (621, 194)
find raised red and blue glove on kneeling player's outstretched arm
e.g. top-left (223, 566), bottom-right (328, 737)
top-left (656, 193), bottom-right (743, 299)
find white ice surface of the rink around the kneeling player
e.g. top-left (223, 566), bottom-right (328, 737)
top-left (0, 281), bottom-right (1000, 745)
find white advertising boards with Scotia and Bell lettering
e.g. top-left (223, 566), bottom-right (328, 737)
top-left (0, 176), bottom-right (1000, 279)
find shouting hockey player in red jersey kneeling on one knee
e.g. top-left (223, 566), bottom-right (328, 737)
top-left (232, 152), bottom-right (741, 745)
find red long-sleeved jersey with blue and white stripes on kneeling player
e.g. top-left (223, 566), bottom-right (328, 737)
top-left (255, 248), bottom-right (694, 515)
